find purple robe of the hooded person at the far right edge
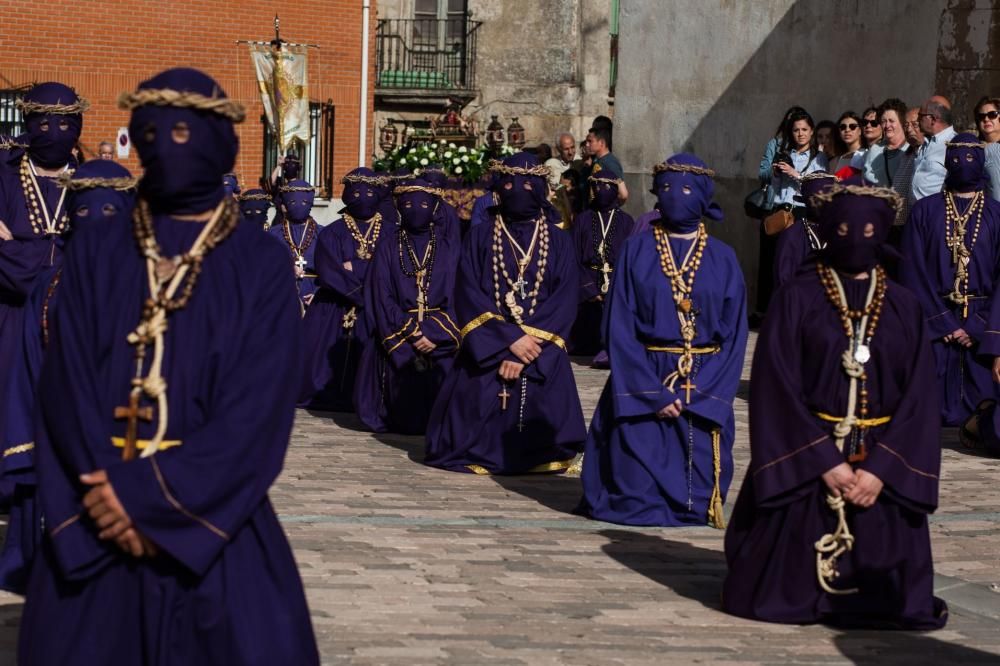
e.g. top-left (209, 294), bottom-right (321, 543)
top-left (899, 194), bottom-right (1000, 425)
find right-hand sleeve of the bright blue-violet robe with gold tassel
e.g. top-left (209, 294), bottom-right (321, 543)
top-left (682, 241), bottom-right (748, 427)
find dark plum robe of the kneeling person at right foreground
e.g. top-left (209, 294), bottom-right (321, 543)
top-left (723, 273), bottom-right (947, 629)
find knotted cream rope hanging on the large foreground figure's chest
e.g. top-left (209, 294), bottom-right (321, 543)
top-left (128, 200), bottom-right (227, 458)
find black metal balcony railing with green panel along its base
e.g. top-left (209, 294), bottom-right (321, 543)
top-left (375, 16), bottom-right (482, 90)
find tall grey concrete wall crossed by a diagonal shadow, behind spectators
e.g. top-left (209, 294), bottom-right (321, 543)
top-left (615, 0), bottom-right (949, 306)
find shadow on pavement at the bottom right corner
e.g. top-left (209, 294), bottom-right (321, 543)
top-left (833, 631), bottom-right (1000, 666)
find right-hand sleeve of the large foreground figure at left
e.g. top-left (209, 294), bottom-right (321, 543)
top-left (107, 244), bottom-right (302, 575)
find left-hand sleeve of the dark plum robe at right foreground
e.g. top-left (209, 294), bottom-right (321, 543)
top-left (752, 284), bottom-right (844, 505)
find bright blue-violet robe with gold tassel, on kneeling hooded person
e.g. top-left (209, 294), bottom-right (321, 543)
top-left (581, 231), bottom-right (747, 526)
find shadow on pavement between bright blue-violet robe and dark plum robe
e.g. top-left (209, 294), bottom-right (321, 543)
top-left (600, 528), bottom-right (726, 610)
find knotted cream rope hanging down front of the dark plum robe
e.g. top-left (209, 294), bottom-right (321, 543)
top-left (815, 269), bottom-right (878, 595)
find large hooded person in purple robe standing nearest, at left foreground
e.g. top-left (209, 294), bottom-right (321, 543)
top-left (18, 69), bottom-right (319, 666)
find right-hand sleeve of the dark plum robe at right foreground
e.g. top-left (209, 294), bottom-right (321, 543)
top-left (858, 294), bottom-right (941, 513)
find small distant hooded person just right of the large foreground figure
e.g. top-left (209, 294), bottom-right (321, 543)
top-left (267, 180), bottom-right (319, 314)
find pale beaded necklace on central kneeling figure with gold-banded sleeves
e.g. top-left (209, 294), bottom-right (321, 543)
top-left (493, 214), bottom-right (549, 324)
